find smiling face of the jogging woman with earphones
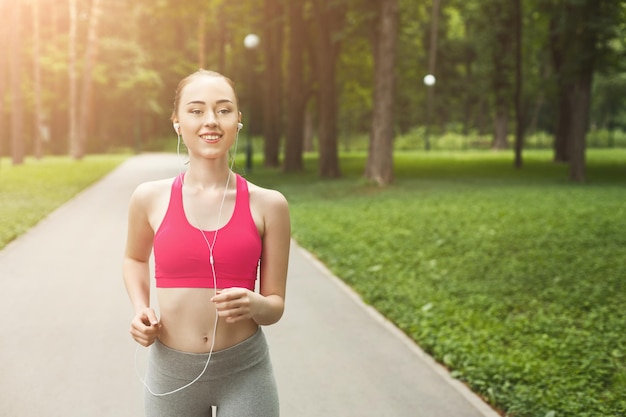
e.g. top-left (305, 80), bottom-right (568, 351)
top-left (177, 75), bottom-right (240, 158)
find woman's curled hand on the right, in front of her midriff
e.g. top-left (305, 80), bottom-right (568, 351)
top-left (211, 287), bottom-right (263, 323)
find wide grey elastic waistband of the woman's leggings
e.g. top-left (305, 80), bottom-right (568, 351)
top-left (148, 327), bottom-right (269, 381)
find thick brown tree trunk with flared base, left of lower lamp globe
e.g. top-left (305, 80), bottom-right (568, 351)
top-left (365, 0), bottom-right (398, 186)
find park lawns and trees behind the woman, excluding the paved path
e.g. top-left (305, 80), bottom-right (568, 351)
top-left (0, 0), bottom-right (626, 417)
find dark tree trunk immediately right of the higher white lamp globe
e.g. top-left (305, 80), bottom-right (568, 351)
top-left (263, 0), bottom-right (284, 167)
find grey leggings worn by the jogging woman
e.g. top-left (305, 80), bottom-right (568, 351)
top-left (144, 328), bottom-right (279, 417)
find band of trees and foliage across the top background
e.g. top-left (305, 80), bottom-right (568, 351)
top-left (0, 0), bottom-right (626, 181)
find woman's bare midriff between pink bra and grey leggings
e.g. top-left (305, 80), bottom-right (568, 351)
top-left (157, 288), bottom-right (259, 353)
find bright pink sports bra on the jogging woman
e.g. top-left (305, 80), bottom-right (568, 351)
top-left (154, 174), bottom-right (261, 291)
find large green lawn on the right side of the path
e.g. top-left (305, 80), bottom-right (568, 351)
top-left (245, 150), bottom-right (626, 417)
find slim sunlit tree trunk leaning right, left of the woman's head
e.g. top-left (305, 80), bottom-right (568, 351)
top-left (74, 0), bottom-right (101, 159)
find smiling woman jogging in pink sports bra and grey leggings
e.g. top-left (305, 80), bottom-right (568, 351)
top-left (123, 70), bottom-right (290, 417)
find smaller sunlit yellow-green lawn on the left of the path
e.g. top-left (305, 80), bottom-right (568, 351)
top-left (0, 155), bottom-right (128, 249)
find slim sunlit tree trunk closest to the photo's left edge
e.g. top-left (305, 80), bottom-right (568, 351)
top-left (9, 2), bottom-right (24, 165)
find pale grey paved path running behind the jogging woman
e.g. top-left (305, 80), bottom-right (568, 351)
top-left (0, 155), bottom-right (497, 417)
